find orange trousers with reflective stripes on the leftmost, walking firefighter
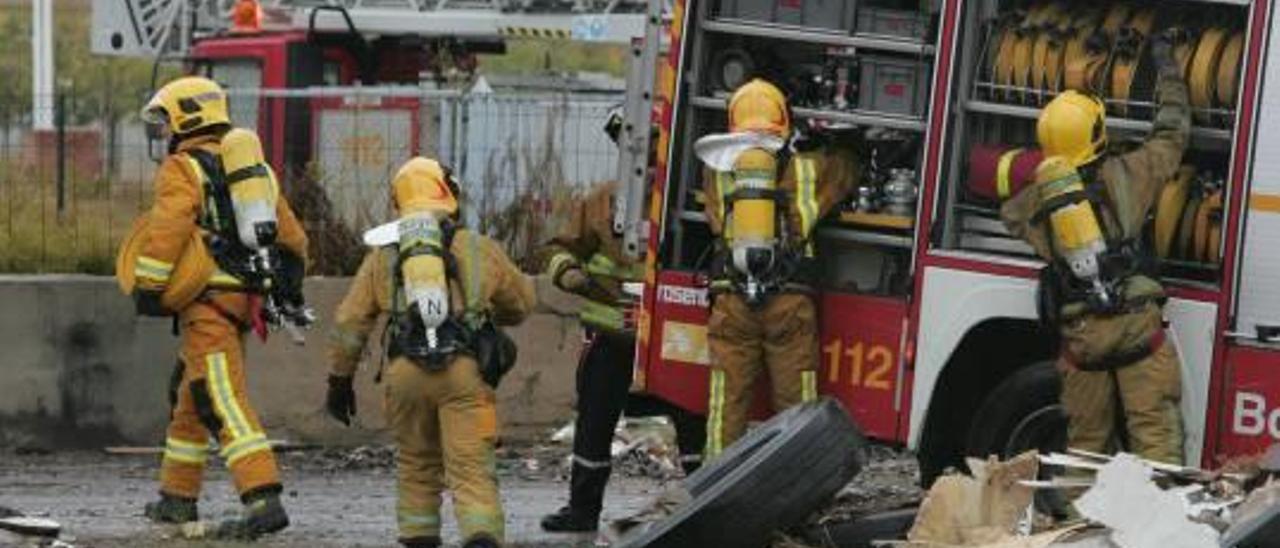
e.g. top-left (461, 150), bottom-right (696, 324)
top-left (160, 293), bottom-right (280, 498)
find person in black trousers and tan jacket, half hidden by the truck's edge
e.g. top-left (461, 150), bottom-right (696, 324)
top-left (541, 182), bottom-right (707, 533)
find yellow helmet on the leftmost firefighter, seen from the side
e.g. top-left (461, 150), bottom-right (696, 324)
top-left (141, 76), bottom-right (230, 134)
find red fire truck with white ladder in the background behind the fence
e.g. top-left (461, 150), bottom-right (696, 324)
top-left (91, 0), bottom-right (663, 184)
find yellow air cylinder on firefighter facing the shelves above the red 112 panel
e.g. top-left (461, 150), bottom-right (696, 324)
top-left (730, 149), bottom-right (778, 275)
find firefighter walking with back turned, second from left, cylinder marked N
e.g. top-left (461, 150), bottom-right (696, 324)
top-left (326, 157), bottom-right (534, 548)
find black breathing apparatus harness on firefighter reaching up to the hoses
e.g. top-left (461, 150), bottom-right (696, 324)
top-left (1032, 163), bottom-right (1155, 326)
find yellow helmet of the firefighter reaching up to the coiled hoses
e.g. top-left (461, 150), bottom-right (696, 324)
top-left (1036, 90), bottom-right (1107, 166)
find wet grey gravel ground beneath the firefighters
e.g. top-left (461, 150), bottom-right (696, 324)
top-left (0, 446), bottom-right (922, 548)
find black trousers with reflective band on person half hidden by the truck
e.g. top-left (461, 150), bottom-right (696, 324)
top-left (570, 333), bottom-right (705, 516)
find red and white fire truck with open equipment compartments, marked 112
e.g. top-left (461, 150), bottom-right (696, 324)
top-left (637, 0), bottom-right (1280, 481)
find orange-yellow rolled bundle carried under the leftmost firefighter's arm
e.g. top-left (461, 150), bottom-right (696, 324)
top-left (115, 214), bottom-right (218, 310)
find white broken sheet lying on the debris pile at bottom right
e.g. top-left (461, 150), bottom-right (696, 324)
top-left (1075, 455), bottom-right (1219, 548)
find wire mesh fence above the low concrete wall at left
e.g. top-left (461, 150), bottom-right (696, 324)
top-left (0, 87), bottom-right (622, 275)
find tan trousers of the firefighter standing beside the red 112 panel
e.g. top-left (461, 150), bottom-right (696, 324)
top-left (707, 293), bottom-right (818, 458)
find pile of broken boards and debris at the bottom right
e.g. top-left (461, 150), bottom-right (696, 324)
top-left (808, 446), bottom-right (1280, 548)
